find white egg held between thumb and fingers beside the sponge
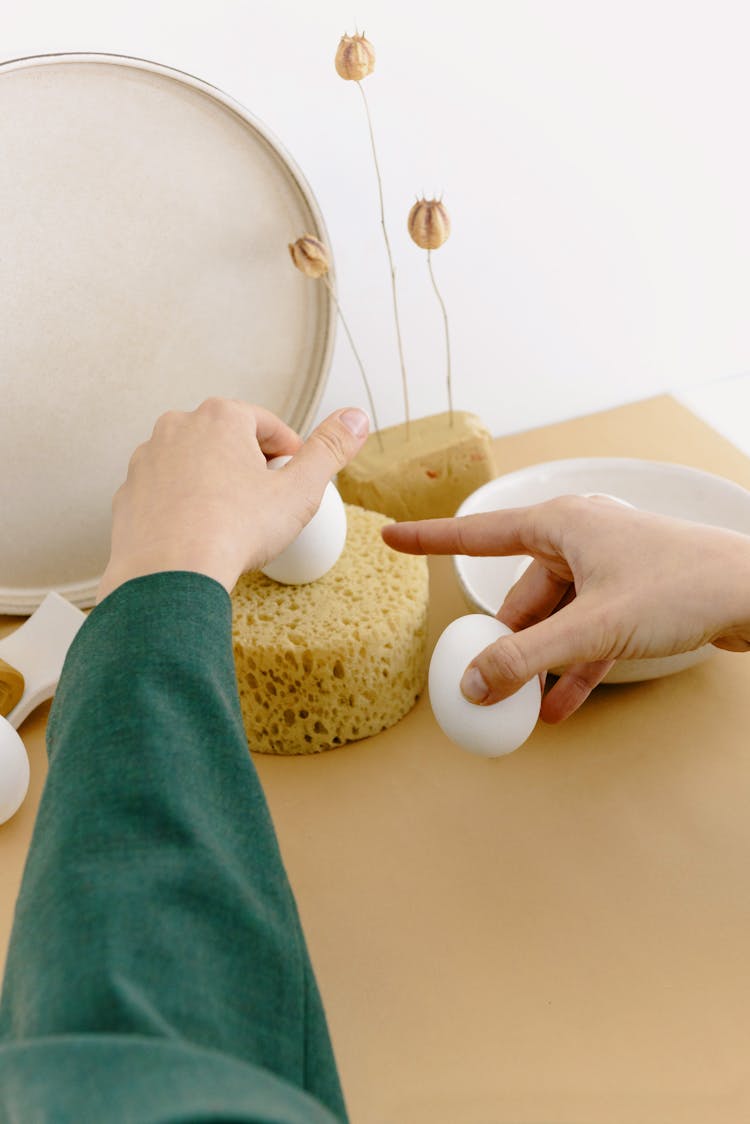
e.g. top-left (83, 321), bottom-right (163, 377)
top-left (428, 613), bottom-right (542, 758)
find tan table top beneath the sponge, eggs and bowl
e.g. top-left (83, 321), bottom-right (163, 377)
top-left (0, 397), bottom-right (750, 1124)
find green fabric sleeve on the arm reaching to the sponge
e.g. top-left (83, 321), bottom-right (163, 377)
top-left (0, 571), bottom-right (346, 1124)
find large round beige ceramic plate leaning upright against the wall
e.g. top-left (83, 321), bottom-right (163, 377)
top-left (0, 54), bottom-right (335, 614)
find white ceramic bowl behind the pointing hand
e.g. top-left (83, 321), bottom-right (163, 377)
top-left (454, 457), bottom-right (750, 683)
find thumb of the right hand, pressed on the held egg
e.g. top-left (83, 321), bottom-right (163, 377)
top-left (461, 601), bottom-right (593, 706)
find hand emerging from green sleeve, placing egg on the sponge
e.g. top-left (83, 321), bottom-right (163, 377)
top-left (97, 398), bottom-right (368, 601)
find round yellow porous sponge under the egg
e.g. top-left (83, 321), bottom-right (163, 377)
top-left (232, 505), bottom-right (428, 754)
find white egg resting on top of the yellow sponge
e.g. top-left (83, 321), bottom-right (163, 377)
top-left (261, 456), bottom-right (346, 586)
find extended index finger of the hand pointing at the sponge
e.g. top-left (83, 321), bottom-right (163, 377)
top-left (381, 507), bottom-right (532, 555)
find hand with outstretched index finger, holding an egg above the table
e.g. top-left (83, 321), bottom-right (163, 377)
top-left (382, 496), bottom-right (750, 722)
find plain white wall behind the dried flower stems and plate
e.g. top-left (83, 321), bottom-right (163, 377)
top-left (5, 0), bottom-right (750, 434)
